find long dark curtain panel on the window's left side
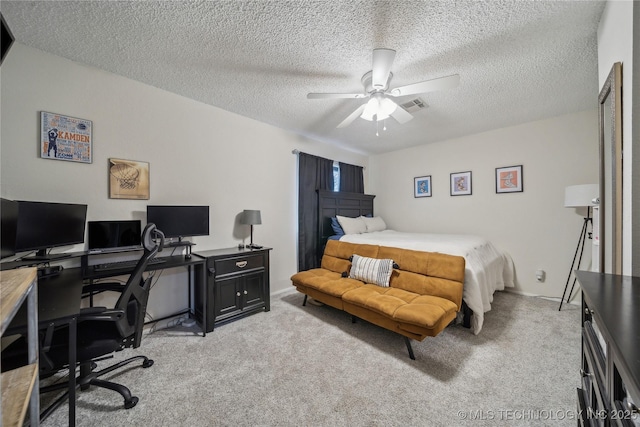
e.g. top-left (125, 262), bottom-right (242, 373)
top-left (298, 153), bottom-right (333, 271)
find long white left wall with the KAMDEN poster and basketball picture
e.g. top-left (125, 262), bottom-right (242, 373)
top-left (0, 43), bottom-right (368, 317)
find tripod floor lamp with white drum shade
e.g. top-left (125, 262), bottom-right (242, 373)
top-left (558, 184), bottom-right (600, 311)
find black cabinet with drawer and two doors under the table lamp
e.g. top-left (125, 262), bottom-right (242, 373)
top-left (195, 247), bottom-right (271, 332)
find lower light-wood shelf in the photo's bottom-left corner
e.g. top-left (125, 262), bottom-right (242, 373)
top-left (0, 363), bottom-right (38, 427)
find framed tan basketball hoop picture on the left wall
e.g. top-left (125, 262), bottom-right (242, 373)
top-left (109, 159), bottom-right (149, 200)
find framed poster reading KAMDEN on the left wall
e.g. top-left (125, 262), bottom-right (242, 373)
top-left (40, 111), bottom-right (93, 163)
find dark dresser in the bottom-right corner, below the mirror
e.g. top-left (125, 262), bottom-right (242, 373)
top-left (576, 271), bottom-right (640, 426)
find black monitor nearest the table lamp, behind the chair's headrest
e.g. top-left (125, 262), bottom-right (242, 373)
top-left (147, 205), bottom-right (209, 240)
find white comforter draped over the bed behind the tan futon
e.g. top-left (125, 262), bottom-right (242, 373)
top-left (340, 230), bottom-right (514, 335)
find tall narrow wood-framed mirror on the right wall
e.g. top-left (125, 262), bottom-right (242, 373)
top-left (598, 62), bottom-right (622, 274)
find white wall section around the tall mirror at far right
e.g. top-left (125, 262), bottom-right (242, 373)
top-left (598, 1), bottom-right (640, 274)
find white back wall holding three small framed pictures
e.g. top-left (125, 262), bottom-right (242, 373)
top-left (369, 112), bottom-right (598, 297)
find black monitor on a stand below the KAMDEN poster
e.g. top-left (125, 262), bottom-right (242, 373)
top-left (16, 201), bottom-right (87, 261)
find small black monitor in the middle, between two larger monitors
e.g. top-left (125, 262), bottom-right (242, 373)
top-left (87, 220), bottom-right (142, 252)
